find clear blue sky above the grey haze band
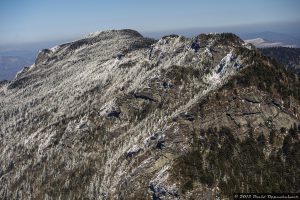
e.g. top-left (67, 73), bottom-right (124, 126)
top-left (0, 0), bottom-right (300, 45)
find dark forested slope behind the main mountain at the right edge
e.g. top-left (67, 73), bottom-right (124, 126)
top-left (260, 47), bottom-right (300, 75)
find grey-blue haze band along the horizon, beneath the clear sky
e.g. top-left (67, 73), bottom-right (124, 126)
top-left (0, 21), bottom-right (300, 53)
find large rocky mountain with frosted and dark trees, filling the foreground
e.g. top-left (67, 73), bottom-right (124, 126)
top-left (0, 30), bottom-right (300, 200)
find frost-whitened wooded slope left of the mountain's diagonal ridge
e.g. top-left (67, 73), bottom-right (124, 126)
top-left (0, 30), bottom-right (253, 198)
